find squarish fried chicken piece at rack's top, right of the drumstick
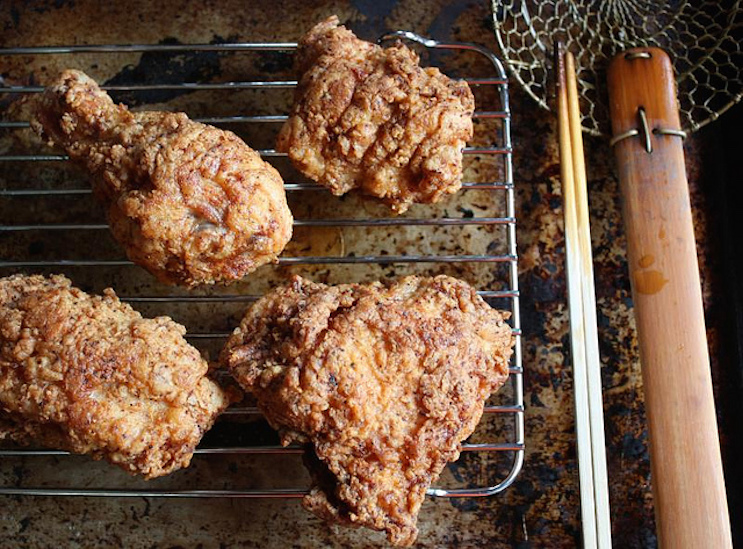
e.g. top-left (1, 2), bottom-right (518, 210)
top-left (277, 16), bottom-right (475, 213)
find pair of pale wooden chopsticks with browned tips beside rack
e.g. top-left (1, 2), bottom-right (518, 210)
top-left (555, 44), bottom-right (611, 549)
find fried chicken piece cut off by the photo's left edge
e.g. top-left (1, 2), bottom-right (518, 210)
top-left (0, 275), bottom-right (229, 478)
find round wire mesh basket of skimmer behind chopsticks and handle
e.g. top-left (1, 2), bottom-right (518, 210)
top-left (492, 0), bottom-right (743, 135)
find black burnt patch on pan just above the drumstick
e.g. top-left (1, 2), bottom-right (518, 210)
top-left (104, 35), bottom-right (235, 106)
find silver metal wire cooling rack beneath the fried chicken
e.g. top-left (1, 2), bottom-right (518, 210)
top-left (0, 31), bottom-right (524, 498)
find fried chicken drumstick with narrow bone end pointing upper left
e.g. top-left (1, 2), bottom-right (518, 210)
top-left (31, 70), bottom-right (292, 286)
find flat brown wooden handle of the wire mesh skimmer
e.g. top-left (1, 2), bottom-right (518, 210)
top-left (608, 48), bottom-right (732, 549)
